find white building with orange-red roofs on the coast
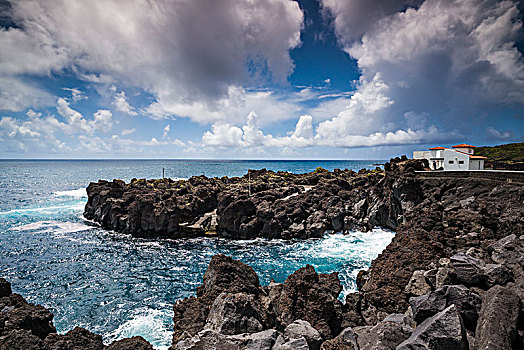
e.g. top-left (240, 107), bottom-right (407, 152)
top-left (413, 143), bottom-right (486, 170)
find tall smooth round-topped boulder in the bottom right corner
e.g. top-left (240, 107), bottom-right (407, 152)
top-left (475, 286), bottom-right (519, 350)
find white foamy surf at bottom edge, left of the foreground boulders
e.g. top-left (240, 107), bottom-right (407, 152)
top-left (104, 308), bottom-right (173, 350)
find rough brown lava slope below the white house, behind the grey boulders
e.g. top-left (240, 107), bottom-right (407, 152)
top-left (357, 165), bottom-right (524, 313)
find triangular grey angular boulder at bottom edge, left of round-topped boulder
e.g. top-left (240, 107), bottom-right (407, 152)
top-left (397, 305), bottom-right (468, 350)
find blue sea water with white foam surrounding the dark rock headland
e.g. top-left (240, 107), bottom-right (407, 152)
top-left (0, 160), bottom-right (393, 348)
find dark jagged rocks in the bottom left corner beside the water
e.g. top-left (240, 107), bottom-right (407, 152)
top-left (0, 278), bottom-right (153, 350)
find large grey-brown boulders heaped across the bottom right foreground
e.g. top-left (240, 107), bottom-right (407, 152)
top-left (172, 228), bottom-right (524, 350)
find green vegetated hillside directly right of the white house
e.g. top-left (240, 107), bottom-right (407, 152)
top-left (475, 142), bottom-right (524, 170)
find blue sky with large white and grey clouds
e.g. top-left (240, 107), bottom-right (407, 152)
top-left (0, 0), bottom-right (524, 159)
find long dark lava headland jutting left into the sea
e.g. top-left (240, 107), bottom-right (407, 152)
top-left (84, 159), bottom-right (426, 239)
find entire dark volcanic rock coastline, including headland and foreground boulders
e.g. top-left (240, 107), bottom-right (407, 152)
top-left (0, 158), bottom-right (524, 350)
